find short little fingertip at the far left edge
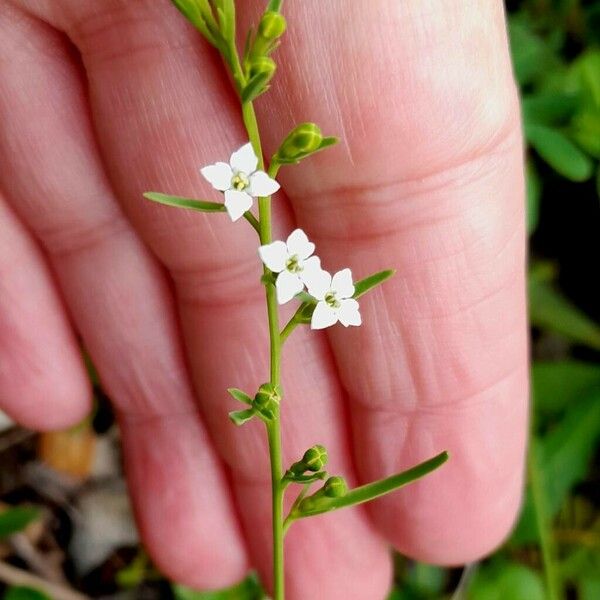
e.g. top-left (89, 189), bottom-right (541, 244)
top-left (0, 197), bottom-right (91, 429)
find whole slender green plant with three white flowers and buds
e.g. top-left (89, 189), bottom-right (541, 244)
top-left (145, 0), bottom-right (448, 600)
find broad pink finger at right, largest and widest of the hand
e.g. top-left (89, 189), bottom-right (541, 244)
top-left (248, 0), bottom-right (527, 563)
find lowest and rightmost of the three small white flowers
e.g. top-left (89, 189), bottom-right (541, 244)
top-left (306, 269), bottom-right (362, 329)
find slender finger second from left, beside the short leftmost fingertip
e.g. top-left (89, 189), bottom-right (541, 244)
top-left (0, 6), bottom-right (246, 587)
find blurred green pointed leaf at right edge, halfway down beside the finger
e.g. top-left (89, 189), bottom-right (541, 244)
top-left (528, 274), bottom-right (600, 350)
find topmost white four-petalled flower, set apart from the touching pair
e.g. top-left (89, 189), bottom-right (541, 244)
top-left (200, 143), bottom-right (280, 221)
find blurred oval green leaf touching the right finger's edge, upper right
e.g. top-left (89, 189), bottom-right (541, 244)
top-left (525, 124), bottom-right (594, 181)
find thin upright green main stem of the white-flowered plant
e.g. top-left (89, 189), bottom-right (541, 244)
top-left (242, 97), bottom-right (285, 600)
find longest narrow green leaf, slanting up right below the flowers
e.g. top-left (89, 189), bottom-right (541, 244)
top-left (293, 452), bottom-right (448, 519)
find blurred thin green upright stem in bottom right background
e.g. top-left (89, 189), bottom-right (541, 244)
top-left (527, 438), bottom-right (562, 600)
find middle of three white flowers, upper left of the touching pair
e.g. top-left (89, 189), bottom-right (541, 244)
top-left (258, 229), bottom-right (321, 304)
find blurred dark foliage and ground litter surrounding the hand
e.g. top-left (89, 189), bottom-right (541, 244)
top-left (0, 0), bottom-right (600, 600)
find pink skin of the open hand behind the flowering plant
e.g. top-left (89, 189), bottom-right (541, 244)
top-left (0, 0), bottom-right (527, 600)
